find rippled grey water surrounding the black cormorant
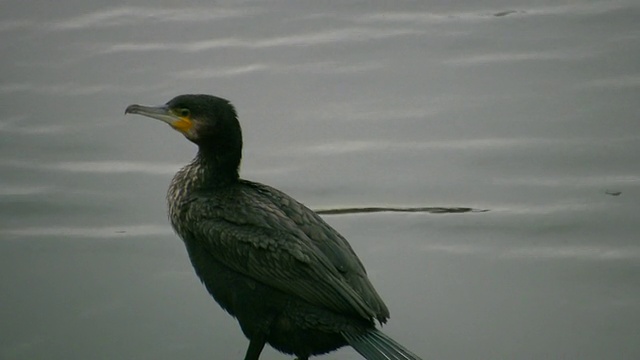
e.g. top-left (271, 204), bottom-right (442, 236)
top-left (0, 0), bottom-right (640, 360)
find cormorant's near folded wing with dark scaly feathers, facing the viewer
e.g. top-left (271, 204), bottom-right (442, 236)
top-left (183, 187), bottom-right (388, 319)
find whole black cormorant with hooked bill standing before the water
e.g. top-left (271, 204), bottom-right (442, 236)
top-left (125, 95), bottom-right (420, 360)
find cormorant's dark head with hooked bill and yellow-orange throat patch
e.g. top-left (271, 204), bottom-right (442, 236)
top-left (125, 95), bottom-right (242, 149)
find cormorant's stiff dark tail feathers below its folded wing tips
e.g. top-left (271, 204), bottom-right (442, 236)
top-left (342, 329), bottom-right (421, 360)
